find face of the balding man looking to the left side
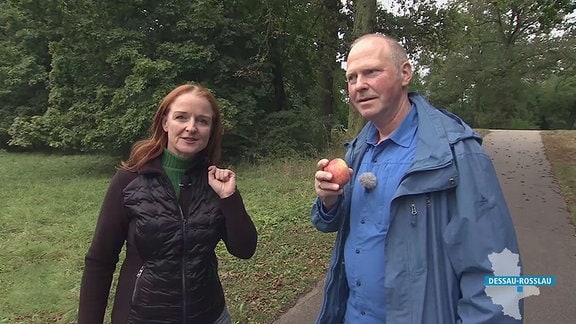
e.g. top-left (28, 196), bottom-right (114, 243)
top-left (346, 37), bottom-right (412, 122)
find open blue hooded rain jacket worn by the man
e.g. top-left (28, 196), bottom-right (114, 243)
top-left (311, 93), bottom-right (523, 324)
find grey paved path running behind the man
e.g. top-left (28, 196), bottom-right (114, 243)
top-left (274, 130), bottom-right (576, 324)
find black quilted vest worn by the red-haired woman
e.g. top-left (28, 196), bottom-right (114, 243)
top-left (124, 161), bottom-right (225, 324)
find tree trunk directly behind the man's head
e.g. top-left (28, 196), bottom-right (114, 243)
top-left (348, 0), bottom-right (376, 137)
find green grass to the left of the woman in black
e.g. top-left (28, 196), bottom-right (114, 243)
top-left (0, 153), bottom-right (119, 323)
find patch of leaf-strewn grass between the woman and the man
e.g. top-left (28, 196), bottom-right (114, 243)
top-left (219, 159), bottom-right (334, 323)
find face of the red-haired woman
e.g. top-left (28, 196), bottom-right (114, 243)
top-left (162, 92), bottom-right (214, 158)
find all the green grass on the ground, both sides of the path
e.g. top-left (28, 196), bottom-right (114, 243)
top-left (0, 131), bottom-right (576, 324)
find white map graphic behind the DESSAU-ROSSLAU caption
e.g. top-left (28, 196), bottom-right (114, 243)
top-left (484, 249), bottom-right (540, 320)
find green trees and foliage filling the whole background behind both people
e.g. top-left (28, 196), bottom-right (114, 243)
top-left (0, 0), bottom-right (576, 160)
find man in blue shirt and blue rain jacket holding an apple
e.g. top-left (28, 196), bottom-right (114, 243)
top-left (311, 34), bottom-right (522, 324)
